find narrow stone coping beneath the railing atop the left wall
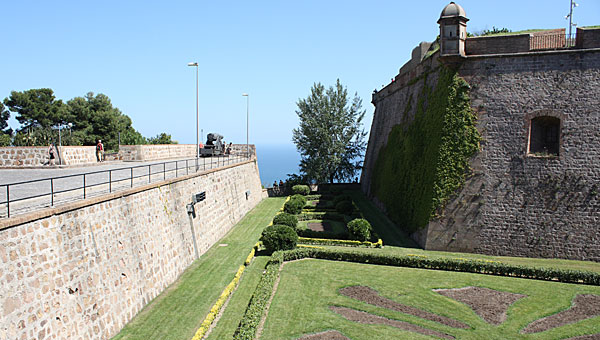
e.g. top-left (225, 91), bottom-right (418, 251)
top-left (0, 158), bottom-right (256, 230)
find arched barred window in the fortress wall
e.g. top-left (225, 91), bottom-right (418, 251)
top-left (529, 116), bottom-right (560, 156)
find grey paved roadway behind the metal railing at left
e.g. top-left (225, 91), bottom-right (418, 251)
top-left (0, 156), bottom-right (246, 218)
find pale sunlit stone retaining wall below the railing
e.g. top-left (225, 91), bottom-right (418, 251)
top-left (0, 160), bottom-right (263, 340)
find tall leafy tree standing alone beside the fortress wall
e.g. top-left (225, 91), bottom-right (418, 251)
top-left (292, 79), bottom-right (366, 183)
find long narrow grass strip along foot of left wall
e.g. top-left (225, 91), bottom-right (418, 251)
top-left (113, 198), bottom-right (285, 340)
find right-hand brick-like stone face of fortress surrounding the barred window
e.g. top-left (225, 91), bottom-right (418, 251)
top-left (454, 50), bottom-right (600, 261)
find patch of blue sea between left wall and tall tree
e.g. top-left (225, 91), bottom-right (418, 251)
top-left (256, 144), bottom-right (300, 188)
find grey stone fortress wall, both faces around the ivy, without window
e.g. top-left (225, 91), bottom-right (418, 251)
top-left (361, 5), bottom-right (600, 261)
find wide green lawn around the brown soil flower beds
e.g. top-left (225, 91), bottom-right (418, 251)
top-left (261, 259), bottom-right (600, 340)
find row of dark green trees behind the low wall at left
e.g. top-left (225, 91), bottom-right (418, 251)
top-left (0, 88), bottom-right (177, 150)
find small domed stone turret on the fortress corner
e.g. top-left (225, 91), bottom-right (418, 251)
top-left (438, 2), bottom-right (469, 58)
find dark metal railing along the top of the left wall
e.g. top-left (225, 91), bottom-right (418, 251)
top-left (0, 154), bottom-right (249, 218)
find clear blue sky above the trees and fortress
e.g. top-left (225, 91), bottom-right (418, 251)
top-left (0, 0), bottom-right (600, 145)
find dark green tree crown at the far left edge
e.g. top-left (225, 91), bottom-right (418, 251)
top-left (4, 89), bottom-right (71, 131)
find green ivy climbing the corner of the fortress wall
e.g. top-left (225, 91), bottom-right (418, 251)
top-left (372, 66), bottom-right (480, 232)
